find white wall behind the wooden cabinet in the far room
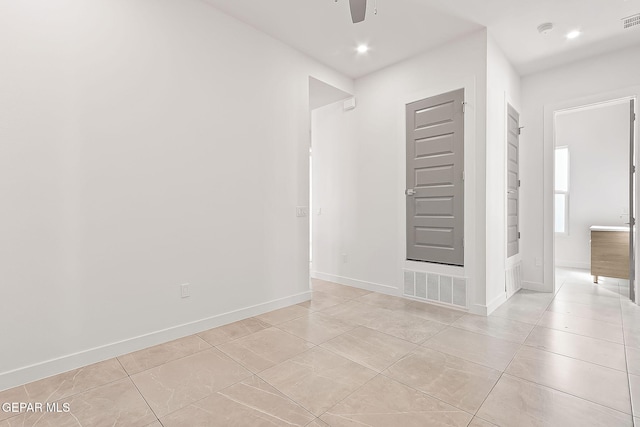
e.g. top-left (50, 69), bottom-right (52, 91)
top-left (555, 101), bottom-right (629, 269)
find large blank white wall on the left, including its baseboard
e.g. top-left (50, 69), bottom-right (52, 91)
top-left (0, 0), bottom-right (353, 390)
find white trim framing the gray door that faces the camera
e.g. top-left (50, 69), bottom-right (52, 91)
top-left (396, 75), bottom-right (486, 310)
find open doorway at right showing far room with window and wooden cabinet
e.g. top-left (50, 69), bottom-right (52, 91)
top-left (553, 97), bottom-right (635, 300)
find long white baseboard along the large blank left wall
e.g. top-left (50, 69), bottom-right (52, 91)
top-left (0, 291), bottom-right (311, 391)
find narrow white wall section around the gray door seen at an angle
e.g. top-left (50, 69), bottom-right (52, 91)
top-left (486, 35), bottom-right (524, 312)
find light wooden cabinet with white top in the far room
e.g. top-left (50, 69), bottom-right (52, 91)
top-left (591, 226), bottom-right (629, 283)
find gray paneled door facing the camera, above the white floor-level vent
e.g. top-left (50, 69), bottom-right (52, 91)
top-left (406, 89), bottom-right (464, 265)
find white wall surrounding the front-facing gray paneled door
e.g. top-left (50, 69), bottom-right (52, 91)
top-left (313, 31), bottom-right (487, 308)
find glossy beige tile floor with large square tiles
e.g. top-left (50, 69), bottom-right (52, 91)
top-left (0, 270), bottom-right (640, 427)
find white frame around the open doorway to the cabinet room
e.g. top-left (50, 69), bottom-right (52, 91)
top-left (544, 86), bottom-right (640, 300)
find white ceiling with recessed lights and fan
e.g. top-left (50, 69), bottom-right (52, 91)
top-left (204, 0), bottom-right (640, 78)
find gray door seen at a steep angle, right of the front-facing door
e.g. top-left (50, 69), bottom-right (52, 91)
top-left (507, 105), bottom-right (520, 258)
